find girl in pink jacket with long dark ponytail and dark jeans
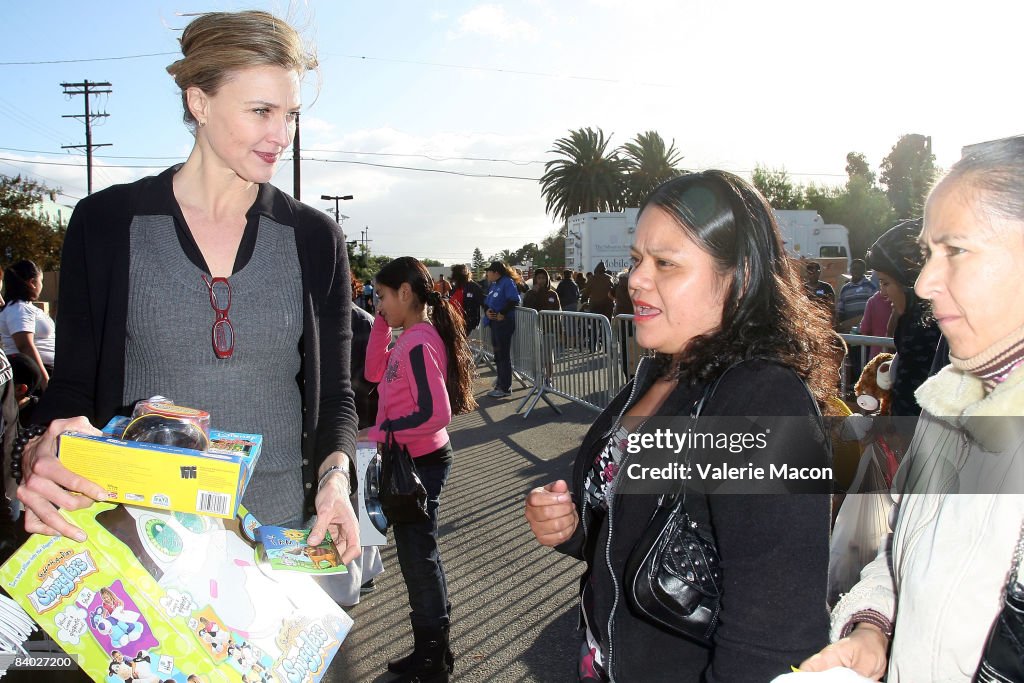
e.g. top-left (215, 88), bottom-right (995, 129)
top-left (365, 256), bottom-right (476, 682)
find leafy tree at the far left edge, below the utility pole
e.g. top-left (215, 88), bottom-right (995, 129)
top-left (0, 175), bottom-right (66, 270)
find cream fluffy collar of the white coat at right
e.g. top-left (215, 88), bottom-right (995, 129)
top-left (914, 366), bottom-right (1024, 451)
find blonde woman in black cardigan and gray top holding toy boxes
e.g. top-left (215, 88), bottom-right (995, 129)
top-left (17, 11), bottom-right (360, 563)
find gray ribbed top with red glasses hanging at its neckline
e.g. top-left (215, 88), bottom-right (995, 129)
top-left (124, 216), bottom-right (303, 526)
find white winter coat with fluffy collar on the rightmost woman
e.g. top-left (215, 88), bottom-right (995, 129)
top-left (831, 360), bottom-right (1024, 683)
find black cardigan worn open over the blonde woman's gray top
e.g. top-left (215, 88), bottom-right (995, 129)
top-left (33, 168), bottom-right (357, 516)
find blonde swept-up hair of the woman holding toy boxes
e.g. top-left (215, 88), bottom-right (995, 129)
top-left (167, 10), bottom-right (318, 130)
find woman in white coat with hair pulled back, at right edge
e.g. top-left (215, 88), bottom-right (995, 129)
top-left (800, 136), bottom-right (1024, 683)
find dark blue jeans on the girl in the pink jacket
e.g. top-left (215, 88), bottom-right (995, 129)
top-left (394, 458), bottom-right (452, 627)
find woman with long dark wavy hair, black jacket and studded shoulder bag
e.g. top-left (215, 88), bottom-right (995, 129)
top-left (526, 171), bottom-right (838, 682)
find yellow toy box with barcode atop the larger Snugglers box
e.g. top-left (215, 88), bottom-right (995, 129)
top-left (58, 417), bottom-right (263, 519)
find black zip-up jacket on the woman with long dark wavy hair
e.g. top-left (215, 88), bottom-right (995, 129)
top-left (557, 359), bottom-right (830, 683)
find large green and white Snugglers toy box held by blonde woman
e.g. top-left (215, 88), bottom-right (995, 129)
top-left (0, 503), bottom-right (352, 683)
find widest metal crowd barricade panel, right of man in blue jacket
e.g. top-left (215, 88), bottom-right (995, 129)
top-left (516, 310), bottom-right (621, 418)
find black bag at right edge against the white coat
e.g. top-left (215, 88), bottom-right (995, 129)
top-left (974, 525), bottom-right (1024, 683)
